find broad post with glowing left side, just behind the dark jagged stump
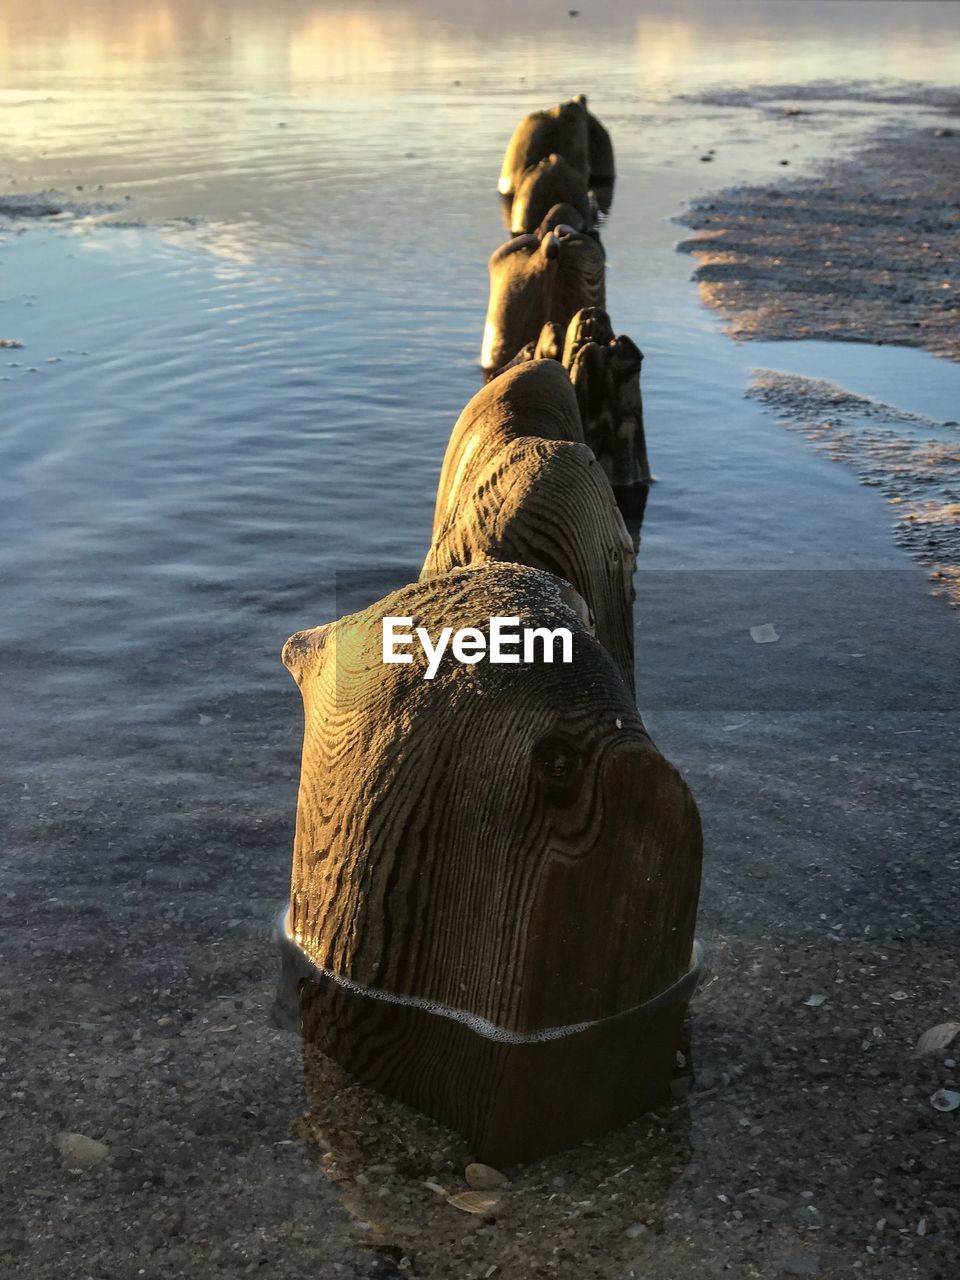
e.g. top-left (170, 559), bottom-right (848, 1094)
top-left (480, 225), bottom-right (605, 376)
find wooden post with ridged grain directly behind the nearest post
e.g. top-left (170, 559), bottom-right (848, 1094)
top-left (421, 436), bottom-right (635, 692)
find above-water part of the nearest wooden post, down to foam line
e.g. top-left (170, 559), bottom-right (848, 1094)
top-left (284, 564), bottom-right (701, 1032)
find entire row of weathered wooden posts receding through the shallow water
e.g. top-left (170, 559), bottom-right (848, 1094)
top-left (283, 97), bottom-right (701, 1164)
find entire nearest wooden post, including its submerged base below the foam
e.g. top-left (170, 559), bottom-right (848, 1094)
top-left (284, 564), bottom-right (700, 1165)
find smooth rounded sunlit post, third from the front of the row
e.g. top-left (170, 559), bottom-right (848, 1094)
top-left (433, 360), bottom-right (584, 538)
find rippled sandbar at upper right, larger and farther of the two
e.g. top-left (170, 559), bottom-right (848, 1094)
top-left (680, 102), bottom-right (960, 360)
